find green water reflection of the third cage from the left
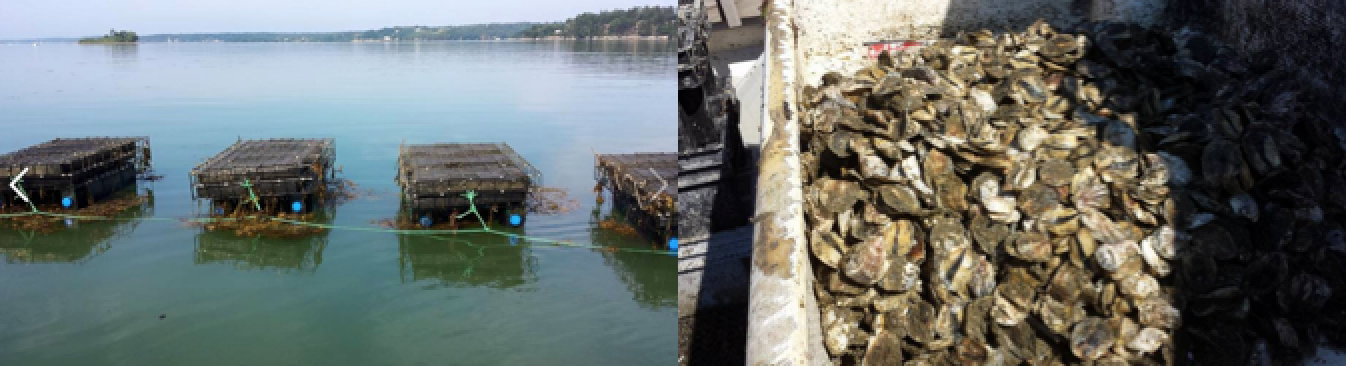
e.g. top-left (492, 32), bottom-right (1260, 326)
top-left (397, 230), bottom-right (537, 289)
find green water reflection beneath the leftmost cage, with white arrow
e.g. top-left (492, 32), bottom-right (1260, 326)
top-left (0, 192), bottom-right (155, 262)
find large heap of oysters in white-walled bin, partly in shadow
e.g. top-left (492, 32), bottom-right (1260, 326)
top-left (801, 22), bottom-right (1346, 365)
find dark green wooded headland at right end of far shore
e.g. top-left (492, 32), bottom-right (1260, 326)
top-left (518, 7), bottom-right (677, 38)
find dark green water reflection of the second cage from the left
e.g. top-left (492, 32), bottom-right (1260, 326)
top-left (195, 213), bottom-right (332, 273)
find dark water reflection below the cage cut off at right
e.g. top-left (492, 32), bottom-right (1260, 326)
top-left (591, 209), bottom-right (677, 308)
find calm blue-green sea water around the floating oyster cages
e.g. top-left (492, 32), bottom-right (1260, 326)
top-left (0, 42), bottom-right (677, 365)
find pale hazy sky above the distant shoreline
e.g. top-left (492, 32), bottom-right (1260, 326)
top-left (0, 0), bottom-right (674, 39)
